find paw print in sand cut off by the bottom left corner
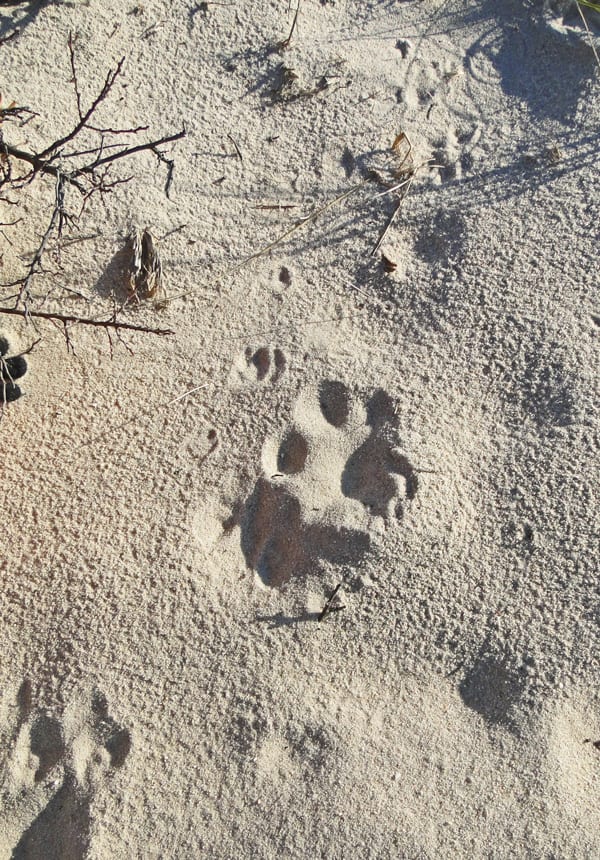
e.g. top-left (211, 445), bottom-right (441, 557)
top-left (0, 681), bottom-right (131, 860)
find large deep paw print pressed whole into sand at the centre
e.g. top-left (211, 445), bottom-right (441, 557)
top-left (239, 380), bottom-right (418, 587)
